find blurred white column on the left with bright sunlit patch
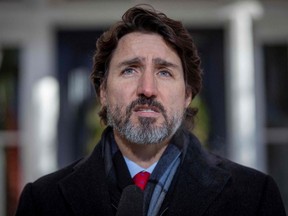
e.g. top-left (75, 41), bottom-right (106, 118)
top-left (20, 17), bottom-right (59, 184)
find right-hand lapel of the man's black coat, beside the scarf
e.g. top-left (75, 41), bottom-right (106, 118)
top-left (168, 132), bottom-right (230, 216)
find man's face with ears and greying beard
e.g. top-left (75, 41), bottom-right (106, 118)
top-left (100, 32), bottom-right (191, 144)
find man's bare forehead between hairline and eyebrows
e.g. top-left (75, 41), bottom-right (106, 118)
top-left (110, 32), bottom-right (182, 66)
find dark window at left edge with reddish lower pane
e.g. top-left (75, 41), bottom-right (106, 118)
top-left (0, 47), bottom-right (20, 216)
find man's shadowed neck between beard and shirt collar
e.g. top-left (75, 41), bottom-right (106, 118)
top-left (114, 130), bottom-right (169, 168)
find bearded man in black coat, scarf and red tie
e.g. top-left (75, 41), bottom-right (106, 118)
top-left (16, 6), bottom-right (285, 216)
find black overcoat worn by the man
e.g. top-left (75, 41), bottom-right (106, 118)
top-left (16, 131), bottom-right (286, 216)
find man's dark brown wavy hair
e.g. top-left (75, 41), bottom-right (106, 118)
top-left (91, 5), bottom-right (202, 128)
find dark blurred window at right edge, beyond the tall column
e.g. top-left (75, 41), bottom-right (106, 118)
top-left (264, 44), bottom-right (288, 211)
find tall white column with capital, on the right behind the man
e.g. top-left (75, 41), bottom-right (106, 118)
top-left (226, 1), bottom-right (262, 168)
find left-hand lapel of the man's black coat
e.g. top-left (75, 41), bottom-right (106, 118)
top-left (59, 146), bottom-right (112, 216)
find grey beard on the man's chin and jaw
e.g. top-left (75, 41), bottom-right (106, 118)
top-left (107, 106), bottom-right (183, 145)
